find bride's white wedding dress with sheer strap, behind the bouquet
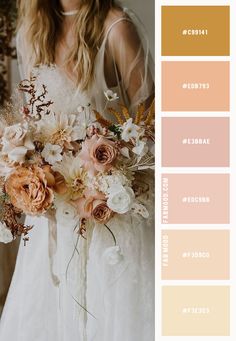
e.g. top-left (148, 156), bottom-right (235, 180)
top-left (0, 8), bottom-right (154, 341)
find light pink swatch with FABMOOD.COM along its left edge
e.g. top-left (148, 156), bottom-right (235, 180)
top-left (161, 174), bottom-right (229, 224)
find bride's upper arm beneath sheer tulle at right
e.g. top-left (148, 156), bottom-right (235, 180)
top-left (108, 20), bottom-right (154, 107)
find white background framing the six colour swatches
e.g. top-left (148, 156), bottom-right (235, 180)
top-left (156, 0), bottom-right (236, 341)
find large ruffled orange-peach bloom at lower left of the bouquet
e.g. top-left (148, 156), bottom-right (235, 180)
top-left (5, 166), bottom-right (54, 215)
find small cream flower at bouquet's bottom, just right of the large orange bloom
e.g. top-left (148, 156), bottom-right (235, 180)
top-left (55, 202), bottom-right (79, 227)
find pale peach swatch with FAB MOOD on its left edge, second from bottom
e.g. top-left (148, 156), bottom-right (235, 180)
top-left (162, 230), bottom-right (230, 280)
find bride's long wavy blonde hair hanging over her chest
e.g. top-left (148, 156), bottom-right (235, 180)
top-left (18, 0), bottom-right (119, 90)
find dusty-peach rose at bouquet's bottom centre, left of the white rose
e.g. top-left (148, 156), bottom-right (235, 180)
top-left (73, 190), bottom-right (113, 224)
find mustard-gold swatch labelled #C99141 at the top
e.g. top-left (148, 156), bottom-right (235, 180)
top-left (162, 6), bottom-right (230, 56)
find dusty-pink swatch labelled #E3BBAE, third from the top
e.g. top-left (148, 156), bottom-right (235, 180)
top-left (162, 117), bottom-right (229, 167)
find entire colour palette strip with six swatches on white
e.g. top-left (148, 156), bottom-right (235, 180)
top-left (156, 0), bottom-right (236, 341)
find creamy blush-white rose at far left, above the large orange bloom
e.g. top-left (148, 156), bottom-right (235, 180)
top-left (1, 123), bottom-right (34, 163)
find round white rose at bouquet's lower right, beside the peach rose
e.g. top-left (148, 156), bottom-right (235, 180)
top-left (107, 185), bottom-right (135, 214)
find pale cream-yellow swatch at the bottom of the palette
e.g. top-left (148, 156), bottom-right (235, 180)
top-left (162, 286), bottom-right (230, 336)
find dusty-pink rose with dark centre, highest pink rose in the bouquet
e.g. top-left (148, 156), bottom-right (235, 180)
top-left (80, 135), bottom-right (119, 175)
